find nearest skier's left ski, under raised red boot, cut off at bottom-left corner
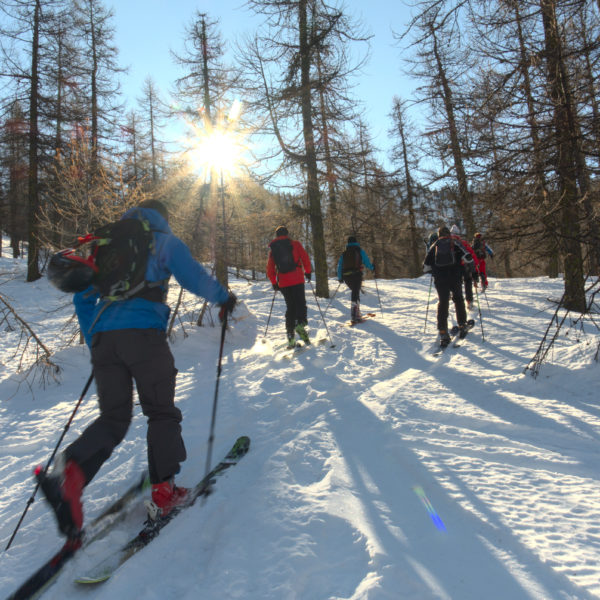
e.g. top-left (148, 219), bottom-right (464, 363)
top-left (8, 472), bottom-right (150, 600)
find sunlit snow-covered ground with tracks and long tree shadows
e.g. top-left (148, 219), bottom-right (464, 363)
top-left (0, 239), bottom-right (600, 600)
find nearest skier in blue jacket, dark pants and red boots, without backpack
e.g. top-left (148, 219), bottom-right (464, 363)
top-left (42, 200), bottom-right (236, 537)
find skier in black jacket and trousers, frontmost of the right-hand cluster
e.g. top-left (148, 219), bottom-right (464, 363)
top-left (423, 226), bottom-right (474, 346)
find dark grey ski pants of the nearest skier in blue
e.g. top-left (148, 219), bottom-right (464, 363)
top-left (65, 329), bottom-right (186, 484)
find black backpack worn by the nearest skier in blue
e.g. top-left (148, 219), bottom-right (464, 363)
top-left (79, 218), bottom-right (165, 302)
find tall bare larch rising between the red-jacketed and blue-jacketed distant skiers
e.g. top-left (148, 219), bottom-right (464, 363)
top-left (241, 0), bottom-right (366, 297)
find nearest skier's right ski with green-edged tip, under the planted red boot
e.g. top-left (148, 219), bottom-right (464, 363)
top-left (75, 436), bottom-right (250, 584)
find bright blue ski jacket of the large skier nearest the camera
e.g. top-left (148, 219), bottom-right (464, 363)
top-left (73, 208), bottom-right (228, 347)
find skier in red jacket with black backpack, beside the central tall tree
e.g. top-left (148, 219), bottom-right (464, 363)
top-left (267, 226), bottom-right (312, 348)
